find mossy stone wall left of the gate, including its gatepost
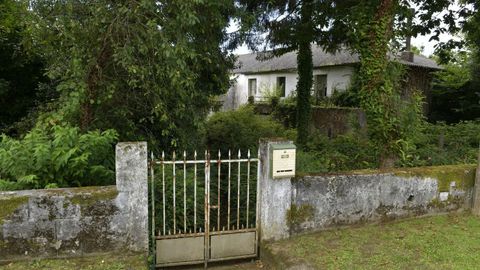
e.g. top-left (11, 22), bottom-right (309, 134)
top-left (0, 143), bottom-right (148, 262)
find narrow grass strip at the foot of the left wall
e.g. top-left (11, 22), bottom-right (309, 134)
top-left (0, 254), bottom-right (147, 270)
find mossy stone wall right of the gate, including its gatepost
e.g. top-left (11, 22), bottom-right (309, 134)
top-left (258, 139), bottom-right (477, 242)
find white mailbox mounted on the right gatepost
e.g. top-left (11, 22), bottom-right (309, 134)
top-left (271, 144), bottom-right (296, 179)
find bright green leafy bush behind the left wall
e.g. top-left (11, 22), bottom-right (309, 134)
top-left (0, 126), bottom-right (117, 190)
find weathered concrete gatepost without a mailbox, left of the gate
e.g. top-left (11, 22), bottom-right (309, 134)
top-left (115, 142), bottom-right (148, 251)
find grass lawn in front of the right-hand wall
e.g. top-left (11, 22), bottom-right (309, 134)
top-left (269, 214), bottom-right (480, 269)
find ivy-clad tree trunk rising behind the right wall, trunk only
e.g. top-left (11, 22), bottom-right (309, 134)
top-left (358, 0), bottom-right (399, 165)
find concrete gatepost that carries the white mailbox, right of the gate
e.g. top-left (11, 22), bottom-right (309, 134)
top-left (258, 140), bottom-right (292, 241)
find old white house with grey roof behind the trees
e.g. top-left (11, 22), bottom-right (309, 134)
top-left (223, 45), bottom-right (440, 110)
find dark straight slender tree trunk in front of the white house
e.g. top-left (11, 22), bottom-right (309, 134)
top-left (297, 0), bottom-right (313, 145)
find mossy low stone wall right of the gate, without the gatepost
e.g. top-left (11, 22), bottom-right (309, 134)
top-left (287, 165), bottom-right (476, 235)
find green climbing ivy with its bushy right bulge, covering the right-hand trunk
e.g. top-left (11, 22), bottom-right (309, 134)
top-left (350, 0), bottom-right (422, 167)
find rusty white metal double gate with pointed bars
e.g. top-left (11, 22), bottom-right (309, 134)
top-left (150, 151), bottom-right (260, 268)
